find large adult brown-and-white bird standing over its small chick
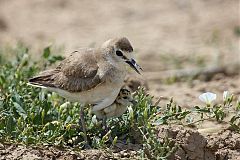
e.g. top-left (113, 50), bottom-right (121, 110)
top-left (28, 37), bottom-right (142, 144)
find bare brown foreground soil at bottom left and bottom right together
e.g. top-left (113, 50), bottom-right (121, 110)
top-left (0, 126), bottom-right (240, 160)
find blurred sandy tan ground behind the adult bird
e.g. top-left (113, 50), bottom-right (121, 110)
top-left (0, 0), bottom-right (240, 106)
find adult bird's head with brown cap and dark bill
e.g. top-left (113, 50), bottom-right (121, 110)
top-left (102, 37), bottom-right (142, 74)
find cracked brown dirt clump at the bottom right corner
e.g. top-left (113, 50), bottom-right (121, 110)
top-left (158, 126), bottom-right (240, 160)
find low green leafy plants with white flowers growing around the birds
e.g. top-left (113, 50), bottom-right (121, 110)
top-left (0, 46), bottom-right (240, 159)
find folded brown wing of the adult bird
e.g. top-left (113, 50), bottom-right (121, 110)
top-left (29, 50), bottom-right (109, 92)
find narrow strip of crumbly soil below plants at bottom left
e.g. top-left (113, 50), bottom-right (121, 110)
top-left (0, 145), bottom-right (137, 160)
